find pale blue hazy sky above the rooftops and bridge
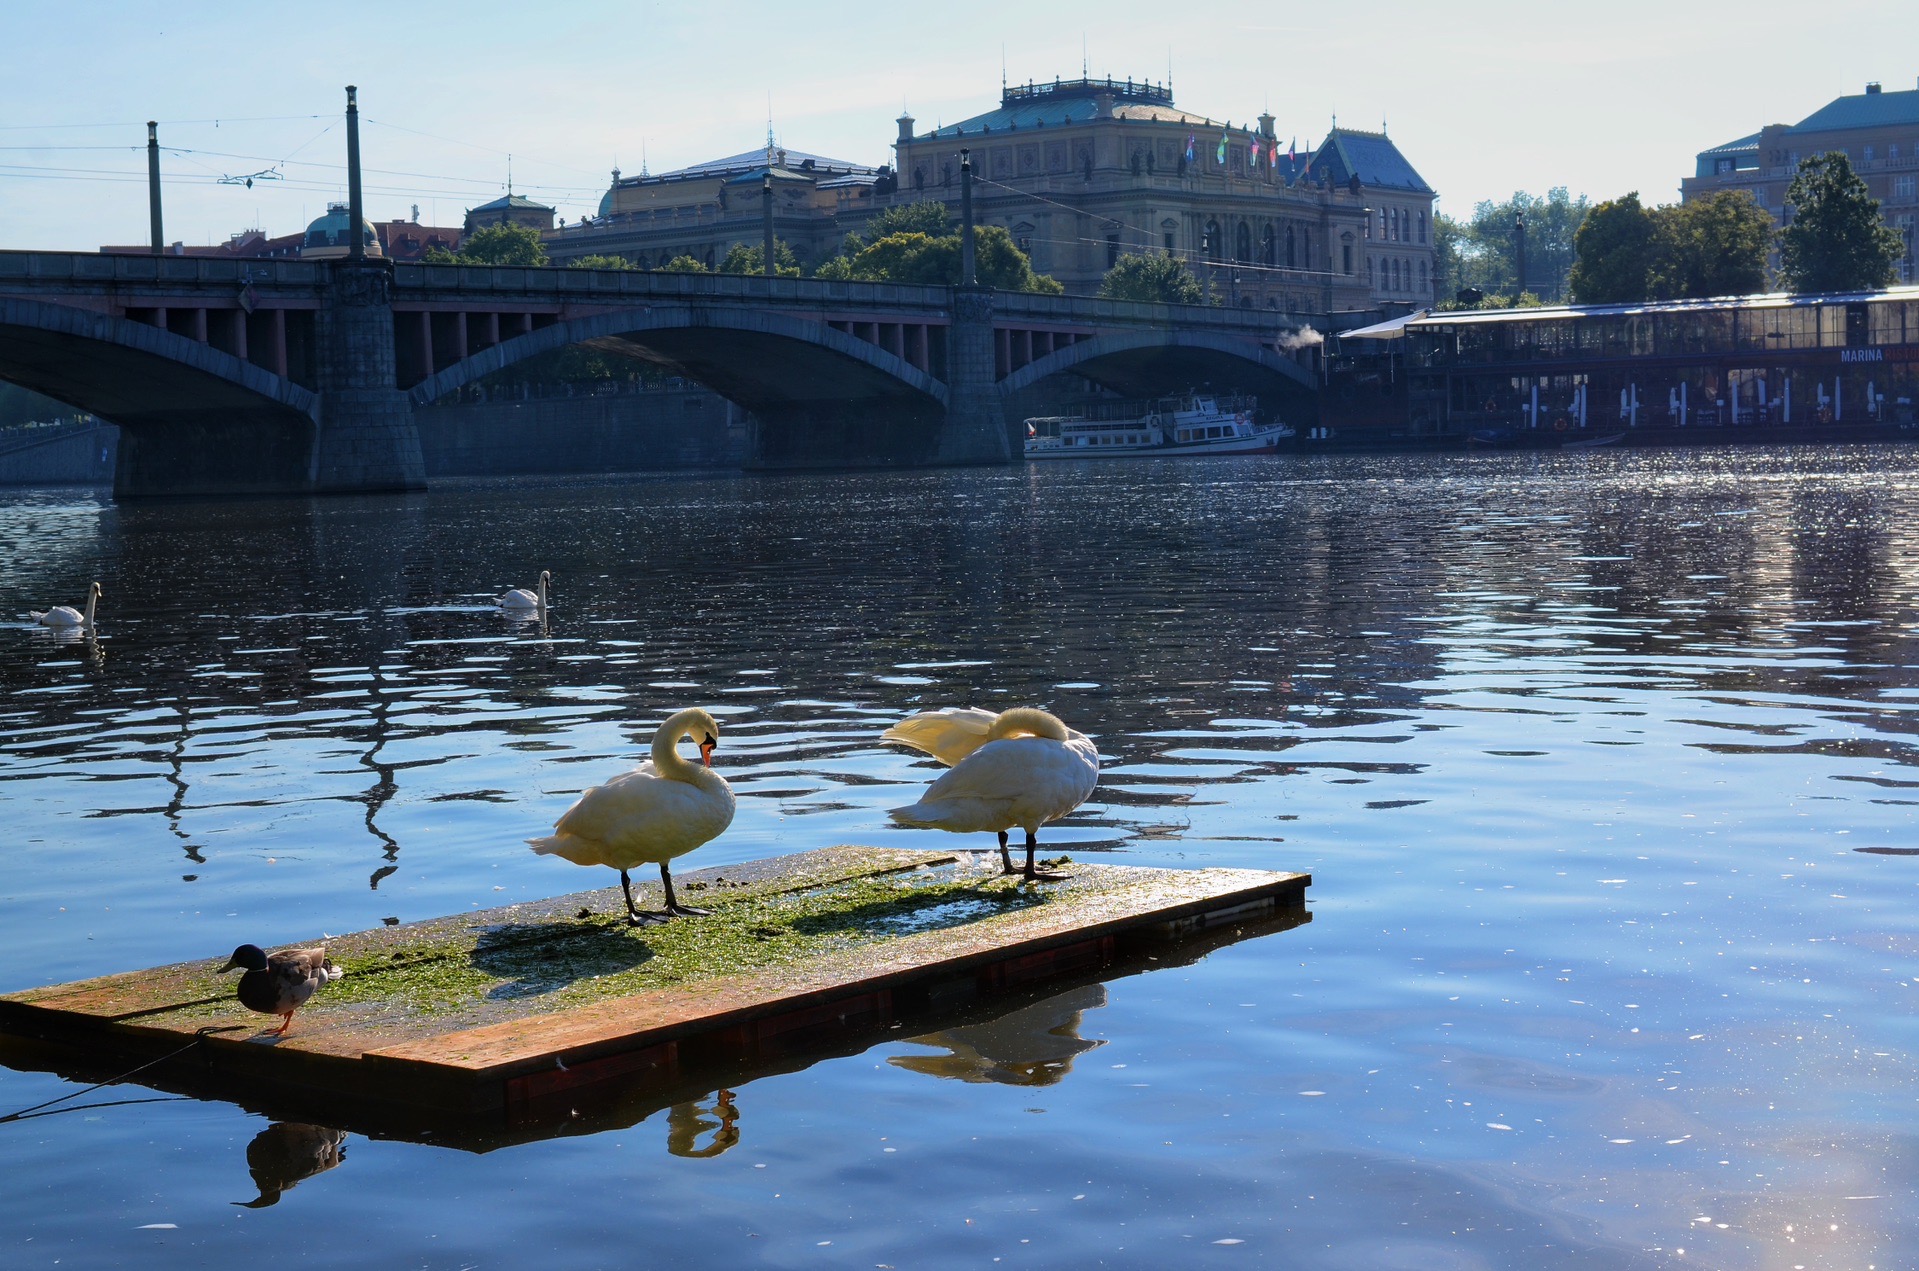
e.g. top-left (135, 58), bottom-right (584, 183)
top-left (0, 0), bottom-right (1919, 252)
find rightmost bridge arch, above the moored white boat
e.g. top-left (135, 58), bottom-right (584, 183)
top-left (1000, 328), bottom-right (1318, 397)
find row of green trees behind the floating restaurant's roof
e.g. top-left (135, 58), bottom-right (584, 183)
top-left (1433, 152), bottom-right (1907, 307)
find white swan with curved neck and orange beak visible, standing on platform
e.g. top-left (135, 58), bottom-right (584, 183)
top-left (528, 707), bottom-right (733, 925)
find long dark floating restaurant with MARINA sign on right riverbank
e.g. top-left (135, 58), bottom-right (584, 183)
top-left (1326, 286), bottom-right (1919, 444)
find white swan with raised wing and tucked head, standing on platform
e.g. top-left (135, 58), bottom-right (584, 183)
top-left (881, 707), bottom-right (1100, 877)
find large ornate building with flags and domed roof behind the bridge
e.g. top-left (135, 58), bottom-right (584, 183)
top-left (547, 79), bottom-right (1433, 315)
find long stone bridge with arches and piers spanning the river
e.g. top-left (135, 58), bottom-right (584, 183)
top-left (0, 252), bottom-right (1315, 497)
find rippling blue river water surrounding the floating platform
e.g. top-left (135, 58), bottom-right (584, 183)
top-left (0, 447), bottom-right (1919, 1269)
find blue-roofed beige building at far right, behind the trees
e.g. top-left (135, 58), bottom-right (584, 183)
top-left (1679, 83), bottom-right (1919, 282)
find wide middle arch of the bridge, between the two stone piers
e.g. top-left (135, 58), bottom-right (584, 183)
top-left (409, 303), bottom-right (948, 415)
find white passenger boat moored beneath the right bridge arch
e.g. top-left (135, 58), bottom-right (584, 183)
top-left (1027, 394), bottom-right (1293, 459)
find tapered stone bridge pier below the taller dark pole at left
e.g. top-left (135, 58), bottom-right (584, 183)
top-left (307, 259), bottom-right (426, 493)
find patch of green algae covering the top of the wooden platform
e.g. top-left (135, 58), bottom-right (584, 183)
top-left (309, 875), bottom-right (1050, 1014)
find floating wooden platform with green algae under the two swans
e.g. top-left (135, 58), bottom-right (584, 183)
top-left (0, 847), bottom-right (1311, 1137)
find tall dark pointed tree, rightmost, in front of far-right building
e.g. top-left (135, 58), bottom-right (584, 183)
top-left (1779, 150), bottom-right (1906, 292)
